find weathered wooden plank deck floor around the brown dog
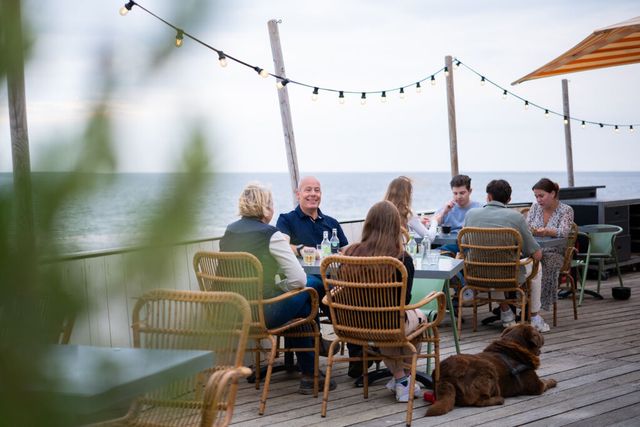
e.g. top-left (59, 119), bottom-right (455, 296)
top-left (228, 272), bottom-right (640, 426)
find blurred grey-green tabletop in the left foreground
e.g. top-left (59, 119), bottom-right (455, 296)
top-left (34, 345), bottom-right (214, 420)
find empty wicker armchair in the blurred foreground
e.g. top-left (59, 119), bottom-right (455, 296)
top-left (94, 290), bottom-right (251, 427)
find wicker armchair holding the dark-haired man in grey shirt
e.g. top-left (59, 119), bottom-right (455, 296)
top-left (458, 227), bottom-right (539, 333)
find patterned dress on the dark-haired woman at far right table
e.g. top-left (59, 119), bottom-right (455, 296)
top-left (527, 202), bottom-right (573, 311)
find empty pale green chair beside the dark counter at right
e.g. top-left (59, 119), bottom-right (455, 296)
top-left (576, 224), bottom-right (623, 305)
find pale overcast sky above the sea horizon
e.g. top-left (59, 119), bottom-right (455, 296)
top-left (0, 0), bottom-right (640, 173)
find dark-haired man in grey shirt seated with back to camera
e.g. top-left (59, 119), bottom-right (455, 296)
top-left (464, 179), bottom-right (549, 332)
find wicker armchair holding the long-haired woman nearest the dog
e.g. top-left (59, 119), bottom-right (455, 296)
top-left (320, 255), bottom-right (445, 425)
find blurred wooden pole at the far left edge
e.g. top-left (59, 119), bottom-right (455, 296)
top-left (0, 0), bottom-right (34, 248)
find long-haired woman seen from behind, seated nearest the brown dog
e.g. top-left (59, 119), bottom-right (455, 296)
top-left (344, 200), bottom-right (427, 402)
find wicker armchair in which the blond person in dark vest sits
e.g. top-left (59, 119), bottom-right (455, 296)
top-left (193, 252), bottom-right (320, 415)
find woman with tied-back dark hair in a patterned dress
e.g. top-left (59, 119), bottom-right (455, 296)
top-left (527, 178), bottom-right (573, 320)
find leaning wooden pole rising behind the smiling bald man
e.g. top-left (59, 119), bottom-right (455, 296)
top-left (267, 19), bottom-right (300, 207)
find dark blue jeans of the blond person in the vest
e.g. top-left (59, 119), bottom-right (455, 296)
top-left (264, 292), bottom-right (314, 375)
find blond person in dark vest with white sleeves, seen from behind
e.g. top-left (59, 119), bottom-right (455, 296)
top-left (220, 183), bottom-right (336, 394)
